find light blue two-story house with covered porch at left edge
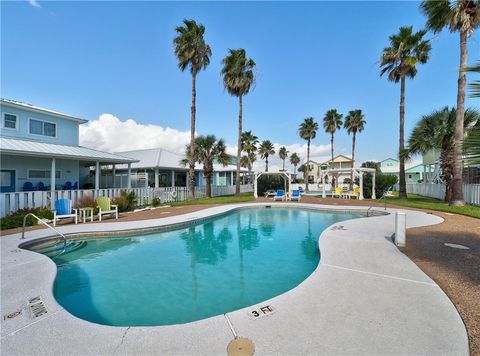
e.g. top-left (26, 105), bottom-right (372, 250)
top-left (0, 99), bottom-right (136, 206)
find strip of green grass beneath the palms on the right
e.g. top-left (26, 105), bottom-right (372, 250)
top-left (387, 194), bottom-right (480, 219)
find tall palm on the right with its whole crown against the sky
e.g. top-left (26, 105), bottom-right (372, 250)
top-left (380, 26), bottom-right (431, 199)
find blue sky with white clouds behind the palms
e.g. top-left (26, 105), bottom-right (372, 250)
top-left (0, 0), bottom-right (480, 172)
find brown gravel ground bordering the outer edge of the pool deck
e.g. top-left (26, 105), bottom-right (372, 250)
top-left (2, 197), bottom-right (480, 355)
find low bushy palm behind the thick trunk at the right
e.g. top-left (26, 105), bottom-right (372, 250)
top-left (406, 107), bottom-right (480, 202)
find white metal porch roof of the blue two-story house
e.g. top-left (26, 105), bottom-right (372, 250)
top-left (0, 137), bottom-right (136, 164)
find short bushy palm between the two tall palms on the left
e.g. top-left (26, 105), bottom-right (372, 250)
top-left (181, 135), bottom-right (230, 198)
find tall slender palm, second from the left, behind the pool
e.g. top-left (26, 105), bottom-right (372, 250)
top-left (221, 48), bottom-right (255, 196)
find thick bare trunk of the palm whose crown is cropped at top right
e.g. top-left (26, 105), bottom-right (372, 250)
top-left (450, 30), bottom-right (467, 206)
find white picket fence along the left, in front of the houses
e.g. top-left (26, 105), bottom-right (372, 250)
top-left (0, 184), bottom-right (253, 217)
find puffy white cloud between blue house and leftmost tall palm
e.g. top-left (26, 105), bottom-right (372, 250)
top-left (80, 114), bottom-right (190, 154)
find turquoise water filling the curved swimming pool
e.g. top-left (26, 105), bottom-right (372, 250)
top-left (45, 208), bottom-right (362, 326)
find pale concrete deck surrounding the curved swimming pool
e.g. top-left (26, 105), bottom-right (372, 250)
top-left (1, 203), bottom-right (469, 355)
